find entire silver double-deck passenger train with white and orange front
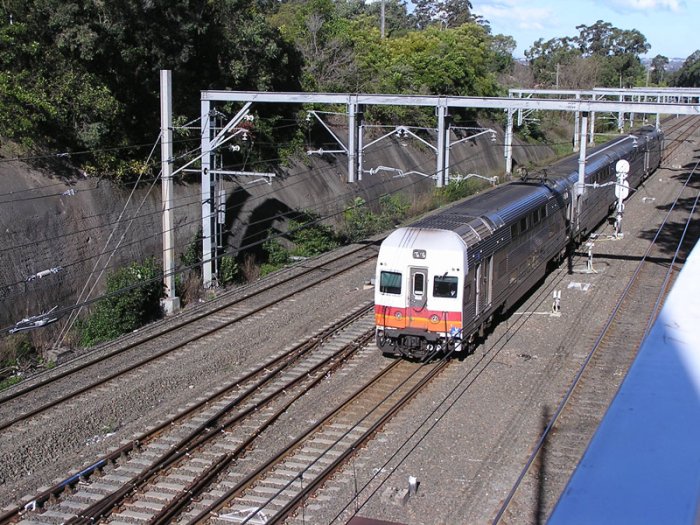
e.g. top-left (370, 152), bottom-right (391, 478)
top-left (374, 127), bottom-right (663, 359)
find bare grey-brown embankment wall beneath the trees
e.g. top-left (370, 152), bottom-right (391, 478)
top-left (0, 123), bottom-right (553, 346)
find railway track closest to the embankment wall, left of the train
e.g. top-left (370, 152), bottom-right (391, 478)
top-left (0, 239), bottom-right (376, 432)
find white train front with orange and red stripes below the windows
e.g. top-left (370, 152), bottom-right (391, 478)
top-left (374, 228), bottom-right (467, 359)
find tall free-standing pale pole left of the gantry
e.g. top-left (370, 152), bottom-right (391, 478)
top-left (160, 69), bottom-right (180, 314)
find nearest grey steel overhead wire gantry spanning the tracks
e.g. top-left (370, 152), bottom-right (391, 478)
top-left (194, 86), bottom-right (700, 286)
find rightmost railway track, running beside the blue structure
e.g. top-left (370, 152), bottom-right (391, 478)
top-left (493, 119), bottom-right (699, 524)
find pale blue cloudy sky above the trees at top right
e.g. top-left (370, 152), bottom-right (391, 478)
top-left (471, 0), bottom-right (700, 59)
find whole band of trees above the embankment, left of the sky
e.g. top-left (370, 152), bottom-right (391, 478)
top-left (0, 0), bottom-right (512, 178)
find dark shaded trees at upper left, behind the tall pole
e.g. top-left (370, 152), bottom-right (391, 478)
top-left (0, 0), bottom-right (299, 175)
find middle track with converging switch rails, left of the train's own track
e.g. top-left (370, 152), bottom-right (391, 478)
top-left (0, 305), bottom-right (372, 523)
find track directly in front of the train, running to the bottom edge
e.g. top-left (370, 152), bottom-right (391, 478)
top-left (176, 360), bottom-right (447, 523)
